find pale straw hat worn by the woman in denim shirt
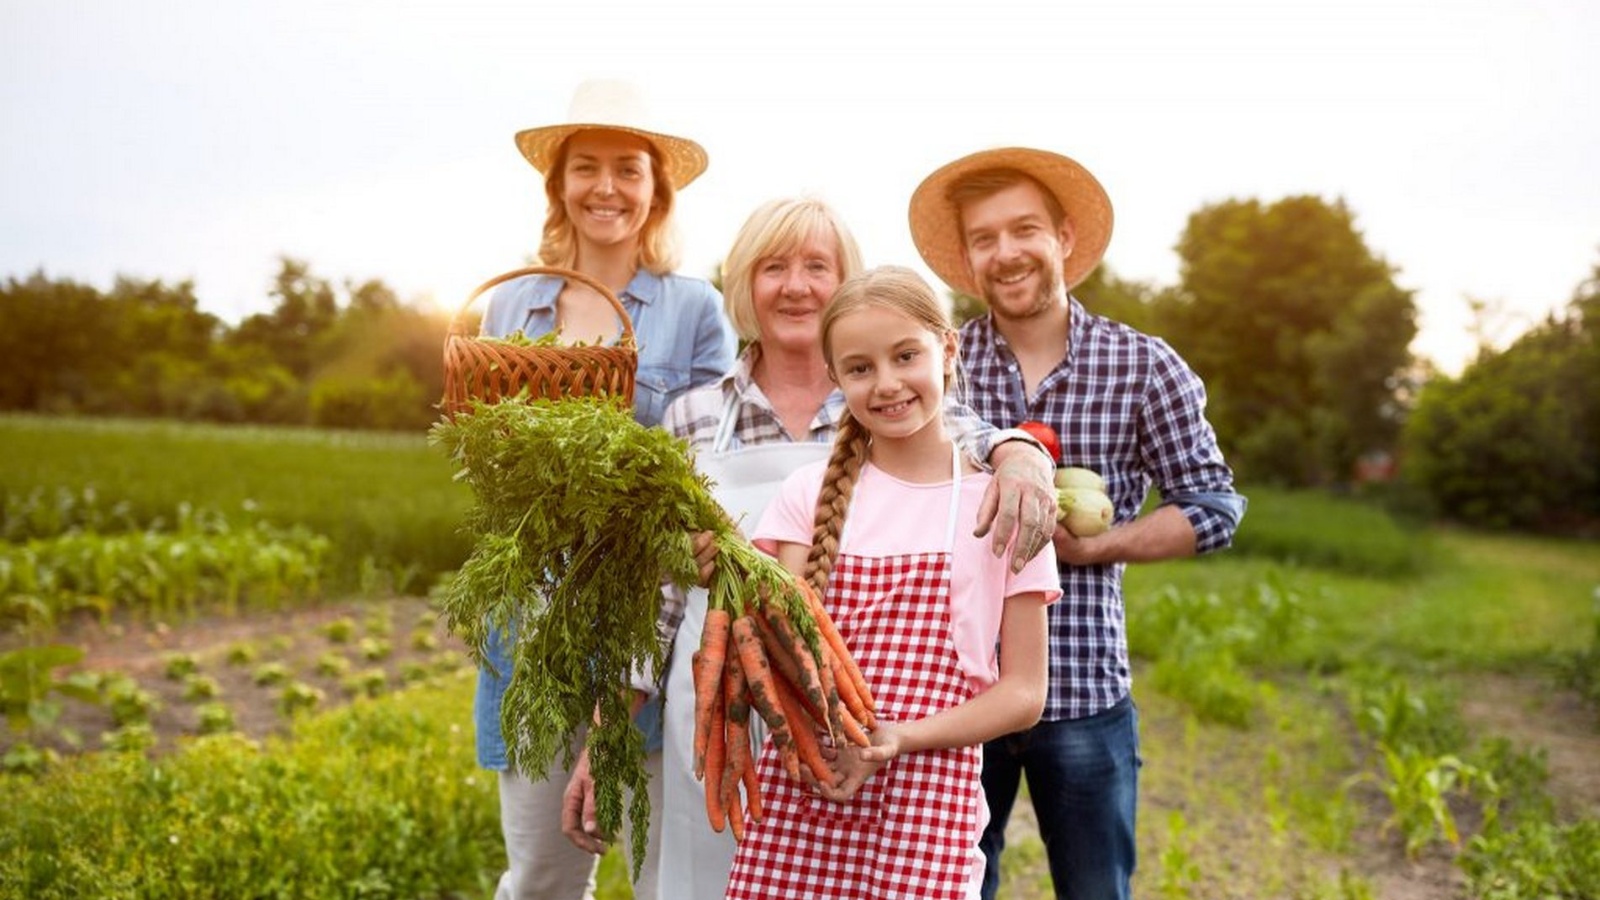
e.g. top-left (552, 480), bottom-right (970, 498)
top-left (517, 78), bottom-right (709, 189)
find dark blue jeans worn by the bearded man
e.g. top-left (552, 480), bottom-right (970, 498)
top-left (979, 697), bottom-right (1142, 900)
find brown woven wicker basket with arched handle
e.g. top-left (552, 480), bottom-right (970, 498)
top-left (440, 266), bottom-right (638, 416)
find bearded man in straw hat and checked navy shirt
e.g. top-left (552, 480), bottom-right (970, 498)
top-left (910, 147), bottom-right (1245, 900)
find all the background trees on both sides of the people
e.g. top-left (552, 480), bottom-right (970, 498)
top-left (9, 195), bottom-right (1600, 533)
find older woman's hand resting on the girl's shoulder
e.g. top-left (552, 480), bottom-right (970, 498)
top-left (973, 440), bottom-right (1056, 572)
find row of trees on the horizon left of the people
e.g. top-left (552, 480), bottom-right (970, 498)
top-left (0, 258), bottom-right (448, 431)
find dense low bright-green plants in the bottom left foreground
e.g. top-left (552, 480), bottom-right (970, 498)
top-left (0, 677), bottom-right (504, 900)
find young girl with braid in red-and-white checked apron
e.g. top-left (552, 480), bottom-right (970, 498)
top-left (728, 267), bottom-right (1059, 900)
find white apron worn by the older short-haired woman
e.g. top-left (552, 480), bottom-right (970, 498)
top-left (661, 396), bottom-right (834, 900)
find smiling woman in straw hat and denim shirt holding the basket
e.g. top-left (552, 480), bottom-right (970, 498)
top-left (474, 82), bottom-right (736, 900)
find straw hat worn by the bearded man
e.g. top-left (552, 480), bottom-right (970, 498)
top-left (910, 147), bottom-right (1112, 296)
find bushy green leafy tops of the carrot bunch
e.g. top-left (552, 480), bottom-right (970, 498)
top-left (429, 392), bottom-right (725, 865)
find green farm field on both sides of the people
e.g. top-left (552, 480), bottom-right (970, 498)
top-left (0, 418), bottom-right (1600, 900)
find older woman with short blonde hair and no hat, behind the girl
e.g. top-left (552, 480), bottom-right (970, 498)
top-left (576, 197), bottom-right (1054, 900)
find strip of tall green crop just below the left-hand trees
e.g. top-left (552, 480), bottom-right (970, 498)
top-left (0, 415), bottom-right (469, 594)
